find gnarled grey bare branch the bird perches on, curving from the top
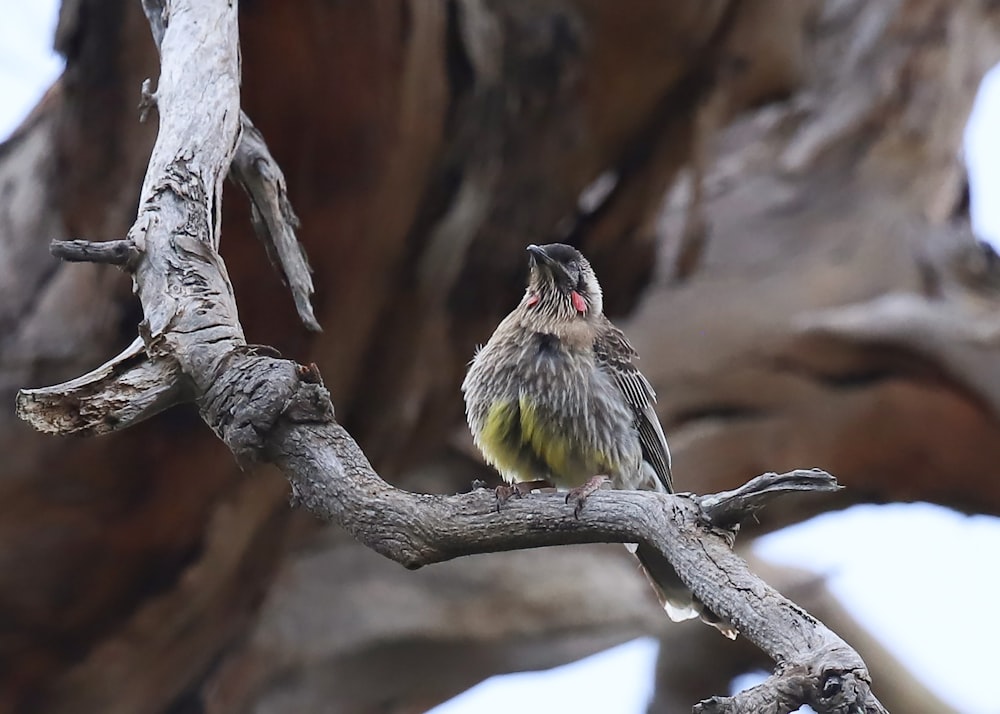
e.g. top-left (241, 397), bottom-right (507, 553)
top-left (17, 0), bottom-right (884, 713)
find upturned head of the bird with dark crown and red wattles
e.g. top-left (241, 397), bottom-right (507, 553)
top-left (523, 243), bottom-right (604, 317)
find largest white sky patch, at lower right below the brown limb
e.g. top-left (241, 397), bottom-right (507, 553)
top-left (754, 503), bottom-right (1000, 714)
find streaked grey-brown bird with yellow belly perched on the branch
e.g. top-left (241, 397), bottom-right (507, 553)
top-left (462, 243), bottom-right (735, 637)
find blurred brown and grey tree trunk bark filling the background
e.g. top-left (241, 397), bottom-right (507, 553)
top-left (0, 0), bottom-right (1000, 711)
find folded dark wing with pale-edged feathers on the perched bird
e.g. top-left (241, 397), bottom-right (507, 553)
top-left (594, 321), bottom-right (674, 493)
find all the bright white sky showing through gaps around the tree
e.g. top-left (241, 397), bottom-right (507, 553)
top-left (0, 0), bottom-right (1000, 714)
